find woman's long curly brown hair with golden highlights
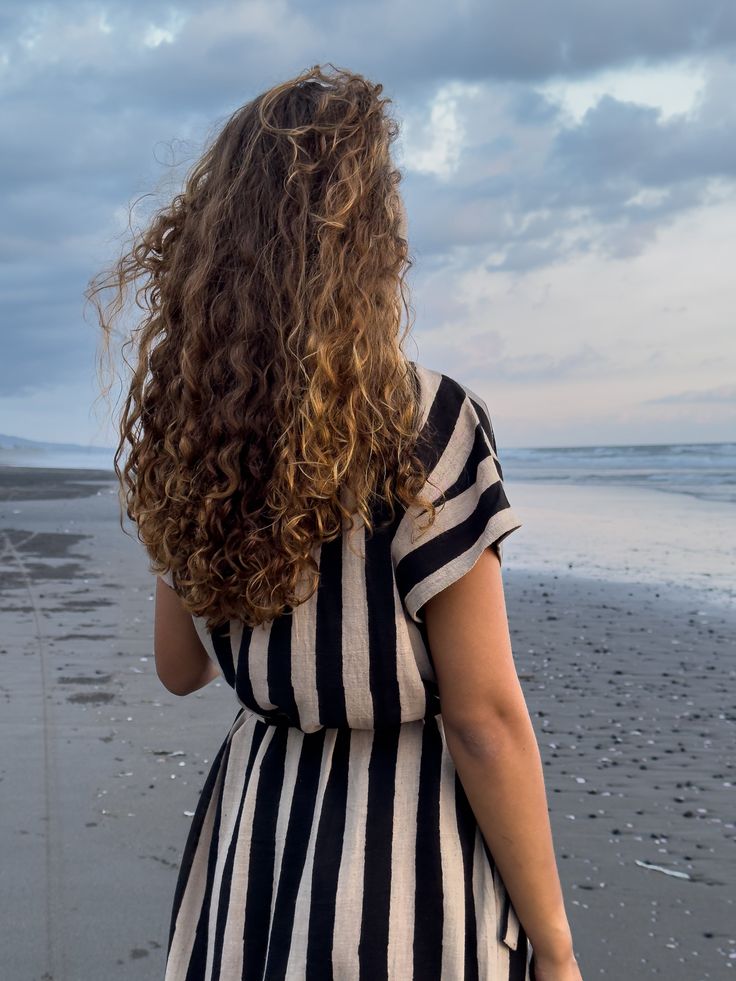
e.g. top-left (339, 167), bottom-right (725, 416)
top-left (85, 63), bottom-right (442, 629)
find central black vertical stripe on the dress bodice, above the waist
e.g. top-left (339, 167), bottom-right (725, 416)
top-left (315, 537), bottom-right (348, 726)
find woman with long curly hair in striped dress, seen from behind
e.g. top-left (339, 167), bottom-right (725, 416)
top-left (88, 66), bottom-right (580, 981)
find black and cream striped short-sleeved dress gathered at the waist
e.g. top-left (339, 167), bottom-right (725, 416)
top-left (164, 362), bottom-right (531, 981)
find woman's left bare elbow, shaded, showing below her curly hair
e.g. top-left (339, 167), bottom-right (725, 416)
top-left (153, 576), bottom-right (220, 695)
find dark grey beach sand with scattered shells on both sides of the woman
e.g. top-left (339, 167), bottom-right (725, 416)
top-left (0, 468), bottom-right (736, 981)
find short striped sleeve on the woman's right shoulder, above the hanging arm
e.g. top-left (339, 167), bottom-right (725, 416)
top-left (391, 375), bottom-right (522, 623)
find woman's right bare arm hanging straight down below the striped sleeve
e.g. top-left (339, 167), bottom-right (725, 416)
top-left (423, 548), bottom-right (580, 981)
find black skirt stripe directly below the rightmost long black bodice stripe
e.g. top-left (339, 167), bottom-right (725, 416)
top-left (358, 726), bottom-right (399, 981)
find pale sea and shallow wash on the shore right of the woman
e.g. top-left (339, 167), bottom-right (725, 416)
top-left (499, 443), bottom-right (736, 606)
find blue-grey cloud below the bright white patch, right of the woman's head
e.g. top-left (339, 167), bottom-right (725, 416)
top-left (410, 70), bottom-right (736, 273)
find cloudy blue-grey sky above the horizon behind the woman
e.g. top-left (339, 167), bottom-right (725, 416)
top-left (0, 0), bottom-right (736, 446)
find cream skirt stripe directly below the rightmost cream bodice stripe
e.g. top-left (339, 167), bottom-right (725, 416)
top-left (388, 720), bottom-right (424, 981)
